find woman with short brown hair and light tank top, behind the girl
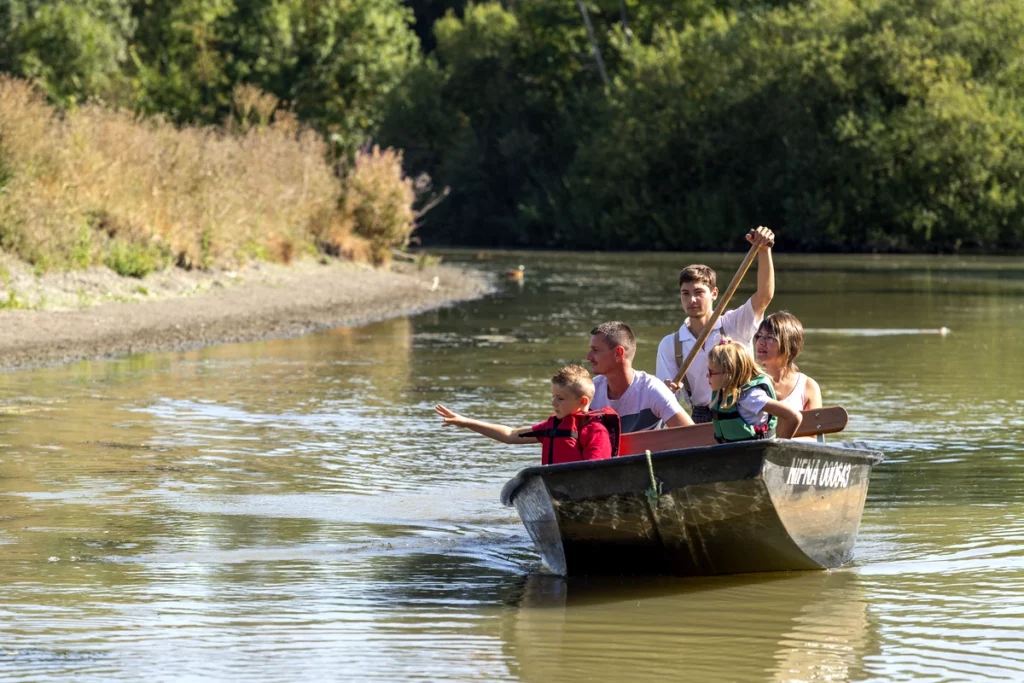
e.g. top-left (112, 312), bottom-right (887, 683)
top-left (754, 310), bottom-right (821, 411)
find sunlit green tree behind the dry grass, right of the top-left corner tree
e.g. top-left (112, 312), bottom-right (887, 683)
top-left (133, 0), bottom-right (420, 151)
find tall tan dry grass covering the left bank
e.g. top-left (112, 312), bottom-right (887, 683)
top-left (0, 77), bottom-right (415, 274)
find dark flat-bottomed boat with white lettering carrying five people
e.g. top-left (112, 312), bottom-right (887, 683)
top-left (502, 409), bottom-right (882, 575)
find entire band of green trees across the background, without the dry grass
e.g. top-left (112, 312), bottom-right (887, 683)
top-left (0, 0), bottom-right (1024, 251)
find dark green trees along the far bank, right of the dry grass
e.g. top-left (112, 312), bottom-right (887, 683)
top-left (382, 0), bottom-right (1024, 250)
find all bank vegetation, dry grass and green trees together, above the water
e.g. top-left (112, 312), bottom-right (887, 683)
top-left (0, 0), bottom-right (1024, 275)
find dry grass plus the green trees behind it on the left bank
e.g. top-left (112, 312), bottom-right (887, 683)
top-left (0, 0), bottom-right (428, 276)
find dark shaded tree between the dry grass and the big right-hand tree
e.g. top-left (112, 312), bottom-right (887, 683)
top-left (381, 0), bottom-right (603, 245)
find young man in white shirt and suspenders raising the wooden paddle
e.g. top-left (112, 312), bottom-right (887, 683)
top-left (654, 226), bottom-right (775, 423)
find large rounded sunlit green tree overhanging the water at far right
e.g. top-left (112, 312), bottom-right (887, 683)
top-left (568, 0), bottom-right (1024, 250)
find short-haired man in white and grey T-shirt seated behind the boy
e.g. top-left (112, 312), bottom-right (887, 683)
top-left (587, 322), bottom-right (693, 433)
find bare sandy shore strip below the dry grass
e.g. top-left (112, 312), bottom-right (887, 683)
top-left (0, 260), bottom-right (492, 370)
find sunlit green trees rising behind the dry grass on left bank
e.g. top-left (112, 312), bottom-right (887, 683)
top-left (0, 0), bottom-right (420, 148)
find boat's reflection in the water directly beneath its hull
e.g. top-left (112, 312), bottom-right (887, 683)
top-left (502, 571), bottom-right (870, 683)
